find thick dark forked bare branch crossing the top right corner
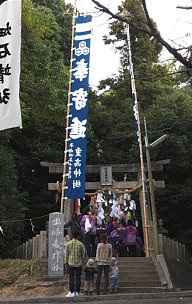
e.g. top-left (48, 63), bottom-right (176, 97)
top-left (92, 0), bottom-right (192, 70)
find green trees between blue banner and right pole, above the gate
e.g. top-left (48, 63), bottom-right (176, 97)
top-left (89, 79), bottom-right (135, 163)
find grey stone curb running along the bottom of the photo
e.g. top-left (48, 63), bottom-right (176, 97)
top-left (0, 290), bottom-right (192, 304)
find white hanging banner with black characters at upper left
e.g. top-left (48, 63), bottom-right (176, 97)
top-left (0, 0), bottom-right (22, 130)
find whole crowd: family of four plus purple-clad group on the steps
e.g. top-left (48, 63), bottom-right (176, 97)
top-left (64, 213), bottom-right (142, 297)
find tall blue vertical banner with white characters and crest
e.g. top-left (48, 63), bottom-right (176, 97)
top-left (65, 15), bottom-right (92, 199)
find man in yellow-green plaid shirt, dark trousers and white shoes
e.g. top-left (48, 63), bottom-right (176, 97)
top-left (64, 230), bottom-right (85, 298)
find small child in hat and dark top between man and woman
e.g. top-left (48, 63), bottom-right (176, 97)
top-left (84, 259), bottom-right (96, 296)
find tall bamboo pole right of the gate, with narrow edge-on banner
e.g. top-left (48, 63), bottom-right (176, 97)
top-left (127, 24), bottom-right (149, 257)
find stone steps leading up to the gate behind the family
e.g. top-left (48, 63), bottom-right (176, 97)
top-left (82, 257), bottom-right (165, 293)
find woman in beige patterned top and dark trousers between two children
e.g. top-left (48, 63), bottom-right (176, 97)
top-left (95, 234), bottom-right (112, 294)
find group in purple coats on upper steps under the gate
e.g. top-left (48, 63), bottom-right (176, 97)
top-left (64, 212), bottom-right (143, 257)
